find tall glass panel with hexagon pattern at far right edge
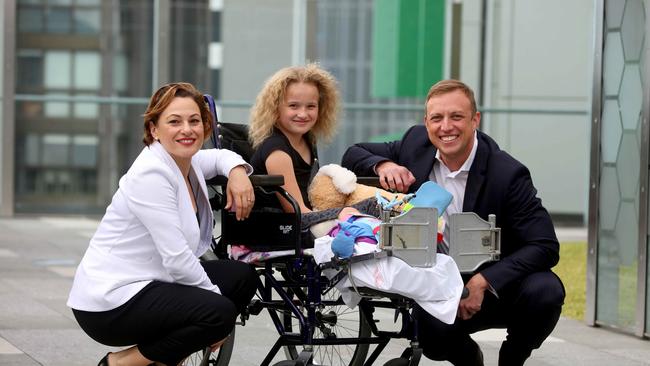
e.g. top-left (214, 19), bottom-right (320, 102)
top-left (587, 0), bottom-right (650, 336)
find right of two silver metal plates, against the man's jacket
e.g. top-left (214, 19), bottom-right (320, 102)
top-left (449, 212), bottom-right (501, 273)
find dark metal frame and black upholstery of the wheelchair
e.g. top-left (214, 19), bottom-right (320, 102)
top-left (190, 95), bottom-right (500, 366)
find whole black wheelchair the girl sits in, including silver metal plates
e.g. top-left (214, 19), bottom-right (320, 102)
top-left (184, 95), bottom-right (500, 366)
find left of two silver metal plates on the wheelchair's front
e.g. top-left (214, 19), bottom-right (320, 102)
top-left (379, 207), bottom-right (438, 267)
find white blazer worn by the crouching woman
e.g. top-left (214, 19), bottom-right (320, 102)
top-left (68, 142), bottom-right (253, 311)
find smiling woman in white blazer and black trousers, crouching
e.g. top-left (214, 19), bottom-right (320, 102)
top-left (68, 83), bottom-right (257, 366)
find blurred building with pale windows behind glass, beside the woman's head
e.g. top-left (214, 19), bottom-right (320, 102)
top-left (8, 0), bottom-right (219, 213)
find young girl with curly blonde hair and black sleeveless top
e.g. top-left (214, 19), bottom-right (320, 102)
top-left (249, 64), bottom-right (376, 227)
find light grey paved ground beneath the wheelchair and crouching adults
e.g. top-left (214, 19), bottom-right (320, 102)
top-left (0, 217), bottom-right (650, 366)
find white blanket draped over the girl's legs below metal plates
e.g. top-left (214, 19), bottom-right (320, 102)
top-left (314, 236), bottom-right (464, 324)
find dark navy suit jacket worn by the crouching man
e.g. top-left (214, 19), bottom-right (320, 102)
top-left (341, 125), bottom-right (559, 292)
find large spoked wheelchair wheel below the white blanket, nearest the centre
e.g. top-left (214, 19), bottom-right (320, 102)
top-left (283, 288), bottom-right (371, 366)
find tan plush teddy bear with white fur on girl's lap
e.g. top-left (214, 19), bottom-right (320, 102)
top-left (308, 164), bottom-right (404, 211)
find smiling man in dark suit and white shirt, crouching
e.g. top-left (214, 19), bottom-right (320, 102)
top-left (342, 80), bottom-right (565, 365)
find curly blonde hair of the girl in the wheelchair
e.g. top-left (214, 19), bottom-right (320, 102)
top-left (248, 63), bottom-right (340, 148)
